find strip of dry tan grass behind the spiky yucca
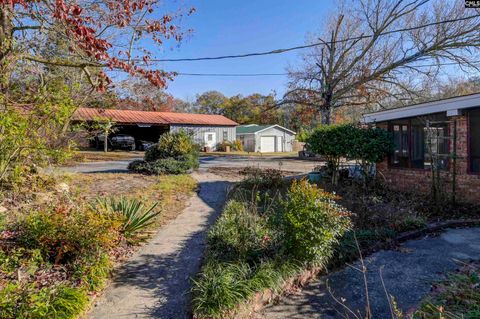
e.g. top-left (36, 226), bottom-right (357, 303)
top-left (0, 173), bottom-right (197, 231)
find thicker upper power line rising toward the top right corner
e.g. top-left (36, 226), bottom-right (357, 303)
top-left (135, 14), bottom-right (480, 62)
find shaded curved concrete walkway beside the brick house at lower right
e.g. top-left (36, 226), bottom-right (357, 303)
top-left (258, 228), bottom-right (480, 319)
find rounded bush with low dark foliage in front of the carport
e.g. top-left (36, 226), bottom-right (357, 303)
top-left (128, 131), bottom-right (199, 175)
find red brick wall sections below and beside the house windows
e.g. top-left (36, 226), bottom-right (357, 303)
top-left (377, 116), bottom-right (480, 202)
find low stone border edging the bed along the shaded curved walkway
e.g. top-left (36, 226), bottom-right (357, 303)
top-left (227, 219), bottom-right (480, 319)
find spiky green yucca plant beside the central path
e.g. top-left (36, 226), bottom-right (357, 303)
top-left (95, 196), bottom-right (160, 237)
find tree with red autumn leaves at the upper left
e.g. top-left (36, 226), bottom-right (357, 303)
top-left (0, 0), bottom-right (194, 93)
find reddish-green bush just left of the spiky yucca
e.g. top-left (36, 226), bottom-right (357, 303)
top-left (17, 207), bottom-right (121, 264)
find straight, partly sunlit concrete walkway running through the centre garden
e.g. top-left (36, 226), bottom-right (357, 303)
top-left (87, 172), bottom-right (228, 319)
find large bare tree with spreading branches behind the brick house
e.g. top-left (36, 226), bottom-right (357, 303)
top-left (280, 0), bottom-right (480, 124)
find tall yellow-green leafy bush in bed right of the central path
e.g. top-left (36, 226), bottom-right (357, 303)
top-left (282, 180), bottom-right (351, 265)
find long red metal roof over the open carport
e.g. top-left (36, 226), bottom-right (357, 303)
top-left (73, 108), bottom-right (238, 126)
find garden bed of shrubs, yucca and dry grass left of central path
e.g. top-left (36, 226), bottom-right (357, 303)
top-left (0, 174), bottom-right (196, 318)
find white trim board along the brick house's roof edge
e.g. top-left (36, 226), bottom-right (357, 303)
top-left (363, 93), bottom-right (480, 123)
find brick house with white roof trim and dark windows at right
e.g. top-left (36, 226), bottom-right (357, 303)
top-left (363, 93), bottom-right (480, 203)
